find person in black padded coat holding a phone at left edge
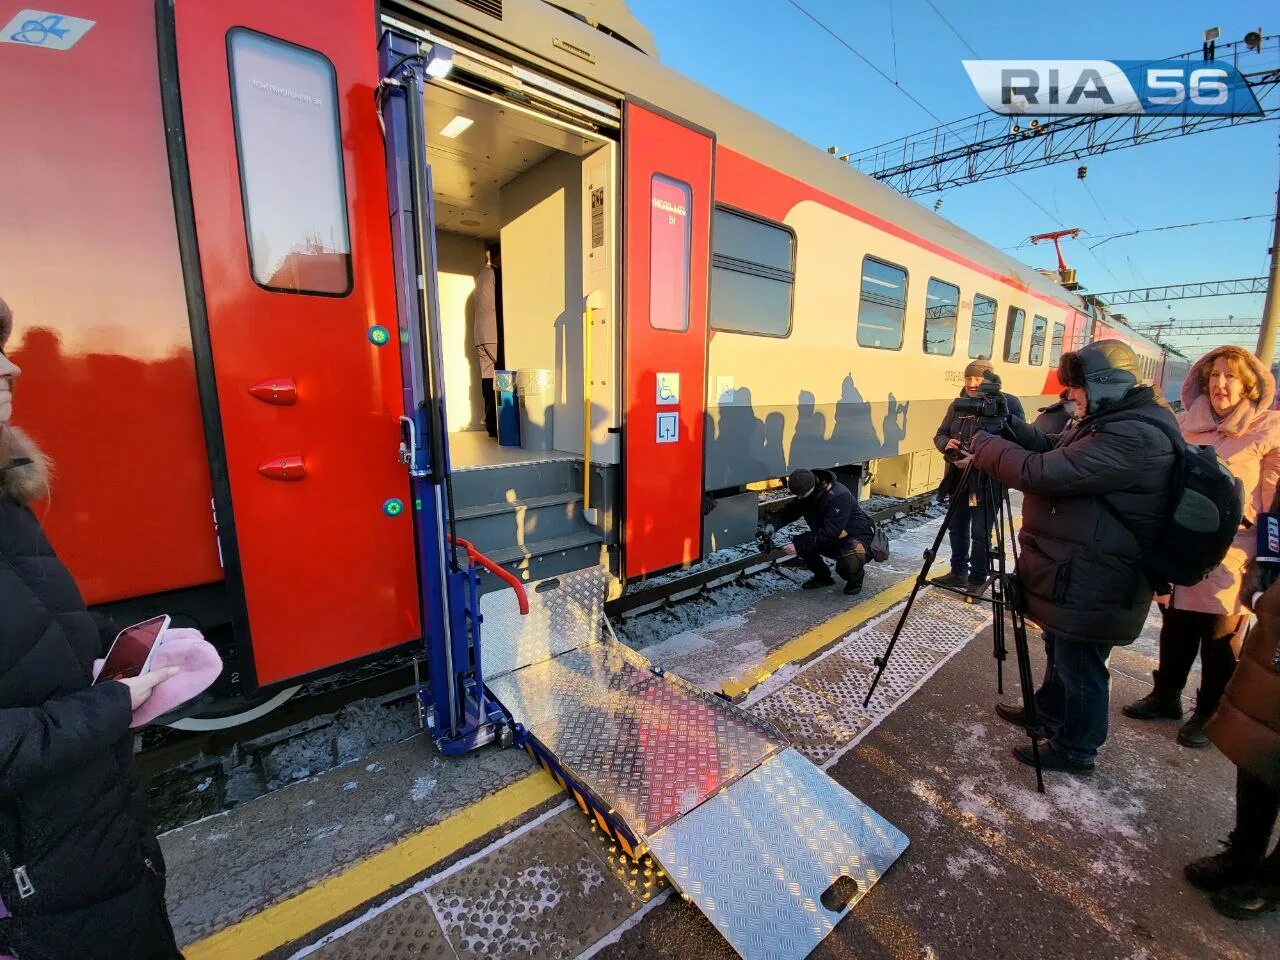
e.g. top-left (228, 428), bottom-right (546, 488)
top-left (0, 300), bottom-right (182, 960)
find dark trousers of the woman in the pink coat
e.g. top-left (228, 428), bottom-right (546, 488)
top-left (1156, 607), bottom-right (1248, 716)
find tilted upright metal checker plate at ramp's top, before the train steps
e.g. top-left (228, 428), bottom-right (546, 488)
top-left (480, 567), bottom-right (609, 680)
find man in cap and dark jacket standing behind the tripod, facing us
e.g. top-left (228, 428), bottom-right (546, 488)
top-left (933, 357), bottom-right (1027, 594)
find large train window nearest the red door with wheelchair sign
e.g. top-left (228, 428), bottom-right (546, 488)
top-left (710, 207), bottom-right (796, 337)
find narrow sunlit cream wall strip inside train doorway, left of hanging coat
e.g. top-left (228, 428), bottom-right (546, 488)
top-left (435, 233), bottom-right (484, 433)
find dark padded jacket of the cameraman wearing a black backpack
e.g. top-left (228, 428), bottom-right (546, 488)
top-left (973, 387), bottom-right (1175, 645)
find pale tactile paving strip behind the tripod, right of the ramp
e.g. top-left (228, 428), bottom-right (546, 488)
top-left (749, 590), bottom-right (991, 764)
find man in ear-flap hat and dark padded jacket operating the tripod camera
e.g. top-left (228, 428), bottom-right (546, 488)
top-left (957, 340), bottom-right (1176, 773)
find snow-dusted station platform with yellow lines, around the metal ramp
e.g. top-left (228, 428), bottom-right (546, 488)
top-left (163, 524), bottom-right (1280, 960)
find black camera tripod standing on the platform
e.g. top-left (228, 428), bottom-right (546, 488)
top-left (863, 461), bottom-right (1048, 794)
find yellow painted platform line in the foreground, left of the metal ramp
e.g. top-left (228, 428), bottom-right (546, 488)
top-left (183, 771), bottom-right (563, 960)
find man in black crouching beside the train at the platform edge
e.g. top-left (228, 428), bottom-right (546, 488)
top-left (773, 470), bottom-right (874, 596)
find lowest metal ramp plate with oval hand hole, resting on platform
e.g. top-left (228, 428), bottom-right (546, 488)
top-left (649, 749), bottom-right (908, 960)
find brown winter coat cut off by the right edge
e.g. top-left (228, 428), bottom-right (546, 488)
top-left (1204, 578), bottom-right (1280, 790)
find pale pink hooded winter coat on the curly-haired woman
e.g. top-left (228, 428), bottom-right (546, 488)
top-left (1172, 355), bottom-right (1280, 616)
